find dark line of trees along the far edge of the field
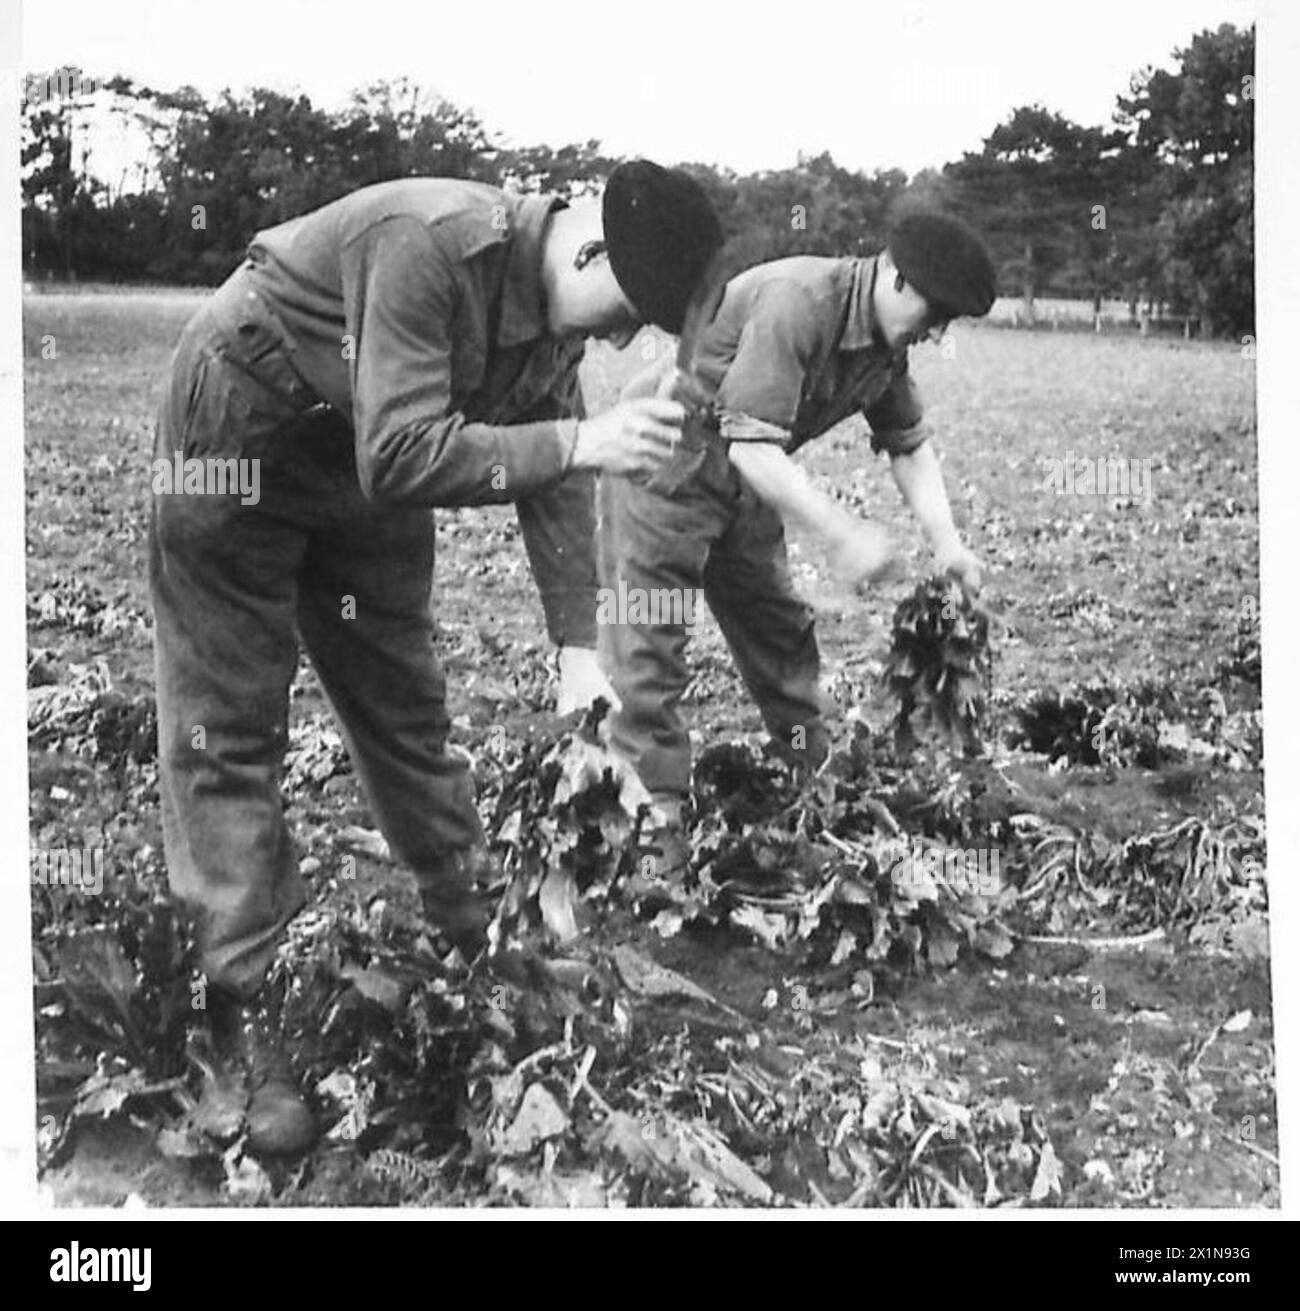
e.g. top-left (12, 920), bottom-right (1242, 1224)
top-left (22, 24), bottom-right (1254, 334)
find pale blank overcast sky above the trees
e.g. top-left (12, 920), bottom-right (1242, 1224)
top-left (24, 0), bottom-right (1255, 173)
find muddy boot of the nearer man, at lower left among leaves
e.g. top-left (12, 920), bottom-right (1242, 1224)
top-left (211, 990), bottom-right (317, 1156)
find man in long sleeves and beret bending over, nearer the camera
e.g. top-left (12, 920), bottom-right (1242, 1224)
top-left (151, 161), bottom-right (721, 1152)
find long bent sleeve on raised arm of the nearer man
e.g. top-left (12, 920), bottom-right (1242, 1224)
top-left (341, 216), bottom-right (577, 506)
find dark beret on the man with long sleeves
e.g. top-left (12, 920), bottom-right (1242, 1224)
top-left (603, 160), bottom-right (722, 333)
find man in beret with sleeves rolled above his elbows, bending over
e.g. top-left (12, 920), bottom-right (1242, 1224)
top-left (598, 211), bottom-right (996, 876)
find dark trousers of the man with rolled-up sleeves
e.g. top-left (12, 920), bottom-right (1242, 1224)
top-left (596, 425), bottom-right (827, 796)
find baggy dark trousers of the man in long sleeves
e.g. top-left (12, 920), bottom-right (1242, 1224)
top-left (149, 275), bottom-right (482, 995)
